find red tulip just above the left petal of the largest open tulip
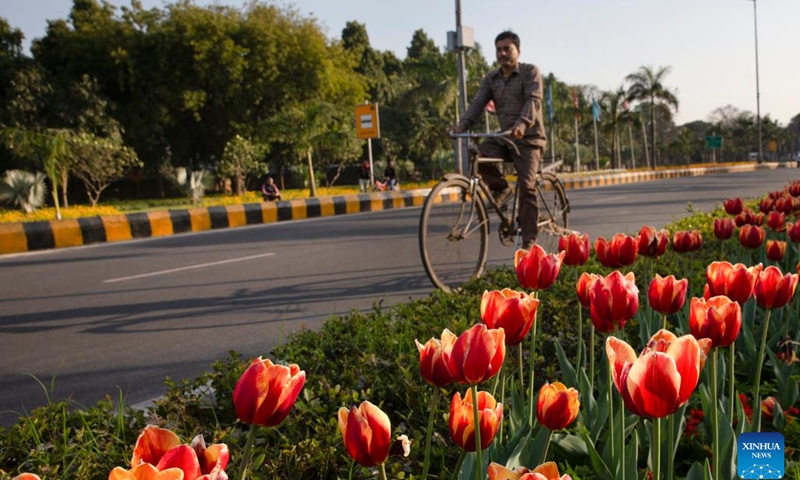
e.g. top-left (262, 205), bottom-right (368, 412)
top-left (589, 270), bottom-right (639, 333)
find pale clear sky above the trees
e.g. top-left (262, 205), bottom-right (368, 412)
top-left (0, 0), bottom-right (800, 126)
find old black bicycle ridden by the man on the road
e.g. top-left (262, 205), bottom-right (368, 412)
top-left (419, 131), bottom-right (571, 292)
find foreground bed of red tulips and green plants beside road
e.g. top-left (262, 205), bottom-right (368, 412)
top-left (0, 183), bottom-right (800, 480)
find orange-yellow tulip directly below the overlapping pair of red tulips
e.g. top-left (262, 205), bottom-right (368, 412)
top-left (449, 389), bottom-right (503, 452)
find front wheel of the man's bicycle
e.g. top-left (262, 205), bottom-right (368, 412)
top-left (419, 179), bottom-right (489, 292)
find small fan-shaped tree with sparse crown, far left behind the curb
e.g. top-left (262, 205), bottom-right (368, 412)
top-left (69, 133), bottom-right (142, 207)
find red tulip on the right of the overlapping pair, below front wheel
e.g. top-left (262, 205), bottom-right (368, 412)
top-left (450, 323), bottom-right (506, 385)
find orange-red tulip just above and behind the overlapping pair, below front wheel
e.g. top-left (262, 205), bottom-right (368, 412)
top-left (481, 288), bottom-right (539, 346)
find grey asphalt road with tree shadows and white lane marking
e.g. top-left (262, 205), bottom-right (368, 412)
top-left (0, 169), bottom-right (800, 425)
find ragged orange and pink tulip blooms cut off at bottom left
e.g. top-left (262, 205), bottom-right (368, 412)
top-left (108, 425), bottom-right (230, 480)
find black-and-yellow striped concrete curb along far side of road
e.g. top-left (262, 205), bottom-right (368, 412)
top-left (0, 162), bottom-right (795, 254)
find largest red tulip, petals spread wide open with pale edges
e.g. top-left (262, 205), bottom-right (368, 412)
top-left (606, 330), bottom-right (703, 418)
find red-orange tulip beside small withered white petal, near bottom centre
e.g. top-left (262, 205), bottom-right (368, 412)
top-left (338, 400), bottom-right (392, 467)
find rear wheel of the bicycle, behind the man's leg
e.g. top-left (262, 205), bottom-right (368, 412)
top-left (536, 173), bottom-right (570, 253)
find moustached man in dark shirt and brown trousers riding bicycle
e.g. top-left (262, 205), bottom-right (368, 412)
top-left (451, 31), bottom-right (547, 250)
